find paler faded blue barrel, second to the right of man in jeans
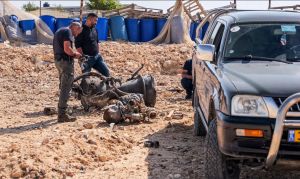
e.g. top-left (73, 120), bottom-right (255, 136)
top-left (109, 16), bottom-right (128, 41)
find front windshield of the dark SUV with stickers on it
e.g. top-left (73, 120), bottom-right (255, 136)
top-left (225, 24), bottom-right (300, 62)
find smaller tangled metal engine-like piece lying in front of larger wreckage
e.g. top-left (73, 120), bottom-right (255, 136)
top-left (103, 94), bottom-right (156, 124)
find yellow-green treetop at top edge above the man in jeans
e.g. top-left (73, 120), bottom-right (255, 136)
top-left (85, 0), bottom-right (122, 10)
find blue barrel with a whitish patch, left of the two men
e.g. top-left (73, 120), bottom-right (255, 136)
top-left (19, 19), bottom-right (37, 43)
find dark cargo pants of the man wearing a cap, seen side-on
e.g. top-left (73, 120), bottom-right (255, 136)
top-left (55, 59), bottom-right (74, 113)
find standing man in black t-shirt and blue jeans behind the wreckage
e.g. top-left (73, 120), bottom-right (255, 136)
top-left (75, 13), bottom-right (109, 77)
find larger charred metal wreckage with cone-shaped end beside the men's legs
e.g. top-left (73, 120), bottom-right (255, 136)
top-left (73, 65), bottom-right (156, 111)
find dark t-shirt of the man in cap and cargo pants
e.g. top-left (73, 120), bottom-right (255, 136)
top-left (53, 27), bottom-right (73, 60)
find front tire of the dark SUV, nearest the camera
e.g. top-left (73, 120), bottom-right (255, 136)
top-left (204, 119), bottom-right (241, 179)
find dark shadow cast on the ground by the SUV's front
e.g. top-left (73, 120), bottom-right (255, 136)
top-left (145, 123), bottom-right (300, 179)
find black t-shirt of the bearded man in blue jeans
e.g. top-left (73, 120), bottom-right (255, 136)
top-left (75, 24), bottom-right (99, 56)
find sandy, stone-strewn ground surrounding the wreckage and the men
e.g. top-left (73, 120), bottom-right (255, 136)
top-left (0, 43), bottom-right (299, 179)
